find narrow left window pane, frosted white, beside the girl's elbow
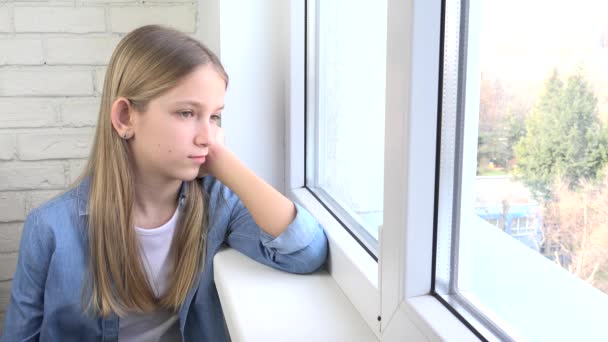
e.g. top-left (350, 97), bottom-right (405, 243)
top-left (306, 0), bottom-right (386, 257)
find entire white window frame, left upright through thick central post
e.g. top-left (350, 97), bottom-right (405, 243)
top-left (285, 0), bottom-right (477, 341)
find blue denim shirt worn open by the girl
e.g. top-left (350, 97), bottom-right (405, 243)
top-left (1, 176), bottom-right (327, 342)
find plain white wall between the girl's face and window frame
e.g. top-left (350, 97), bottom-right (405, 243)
top-left (214, 0), bottom-right (289, 191)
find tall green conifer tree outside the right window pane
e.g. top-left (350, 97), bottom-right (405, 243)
top-left (515, 69), bottom-right (608, 199)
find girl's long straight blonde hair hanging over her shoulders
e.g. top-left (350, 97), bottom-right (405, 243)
top-left (81, 25), bottom-right (228, 317)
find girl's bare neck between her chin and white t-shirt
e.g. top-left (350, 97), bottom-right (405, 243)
top-left (133, 177), bottom-right (182, 228)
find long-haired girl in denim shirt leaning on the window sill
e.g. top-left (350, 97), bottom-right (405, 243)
top-left (2, 26), bottom-right (327, 342)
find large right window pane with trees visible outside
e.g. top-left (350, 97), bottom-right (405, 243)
top-left (433, 0), bottom-right (608, 341)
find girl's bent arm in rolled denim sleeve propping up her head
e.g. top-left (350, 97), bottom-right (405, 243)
top-left (203, 129), bottom-right (328, 273)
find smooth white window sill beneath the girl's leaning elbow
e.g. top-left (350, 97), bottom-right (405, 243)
top-left (214, 249), bottom-right (377, 342)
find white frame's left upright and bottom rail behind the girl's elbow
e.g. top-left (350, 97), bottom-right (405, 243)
top-left (285, 0), bottom-right (380, 339)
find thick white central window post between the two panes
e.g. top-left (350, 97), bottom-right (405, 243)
top-left (380, 0), bottom-right (478, 340)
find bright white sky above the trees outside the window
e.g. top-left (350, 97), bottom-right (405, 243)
top-left (478, 0), bottom-right (608, 113)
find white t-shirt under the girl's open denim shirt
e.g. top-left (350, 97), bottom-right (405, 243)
top-left (118, 207), bottom-right (181, 342)
